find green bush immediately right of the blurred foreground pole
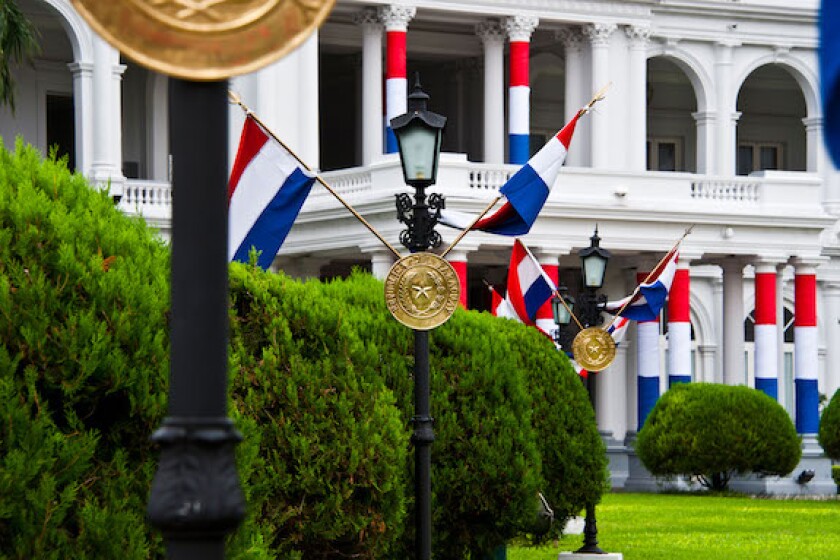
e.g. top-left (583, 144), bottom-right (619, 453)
top-left (230, 264), bottom-right (407, 558)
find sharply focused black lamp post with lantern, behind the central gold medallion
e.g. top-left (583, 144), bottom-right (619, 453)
top-left (391, 75), bottom-right (446, 560)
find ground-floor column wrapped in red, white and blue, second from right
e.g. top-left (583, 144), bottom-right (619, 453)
top-left (755, 262), bottom-right (779, 400)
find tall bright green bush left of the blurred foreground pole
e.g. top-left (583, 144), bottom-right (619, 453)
top-left (0, 142), bottom-right (169, 559)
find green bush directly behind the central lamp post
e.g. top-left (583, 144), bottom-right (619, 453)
top-left (321, 274), bottom-right (550, 559)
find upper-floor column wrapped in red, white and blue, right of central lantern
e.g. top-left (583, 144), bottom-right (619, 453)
top-left (502, 15), bottom-right (540, 164)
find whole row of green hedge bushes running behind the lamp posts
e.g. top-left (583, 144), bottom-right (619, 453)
top-left (0, 139), bottom-right (605, 560)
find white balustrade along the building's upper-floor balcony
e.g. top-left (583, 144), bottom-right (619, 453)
top-left (119, 154), bottom-right (823, 236)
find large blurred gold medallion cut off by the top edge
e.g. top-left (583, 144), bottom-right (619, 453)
top-left (72, 0), bottom-right (335, 80)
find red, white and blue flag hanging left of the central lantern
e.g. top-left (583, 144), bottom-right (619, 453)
top-left (228, 115), bottom-right (315, 269)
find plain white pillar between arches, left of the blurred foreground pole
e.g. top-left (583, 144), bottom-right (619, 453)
top-left (91, 35), bottom-right (125, 196)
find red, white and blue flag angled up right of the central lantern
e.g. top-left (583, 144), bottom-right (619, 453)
top-left (439, 110), bottom-right (585, 235)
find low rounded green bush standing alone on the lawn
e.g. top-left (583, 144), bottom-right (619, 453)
top-left (636, 383), bottom-right (802, 490)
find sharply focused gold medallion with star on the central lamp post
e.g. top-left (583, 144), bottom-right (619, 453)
top-left (385, 253), bottom-right (461, 331)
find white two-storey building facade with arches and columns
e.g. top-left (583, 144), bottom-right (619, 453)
top-left (6, 0), bottom-right (840, 485)
